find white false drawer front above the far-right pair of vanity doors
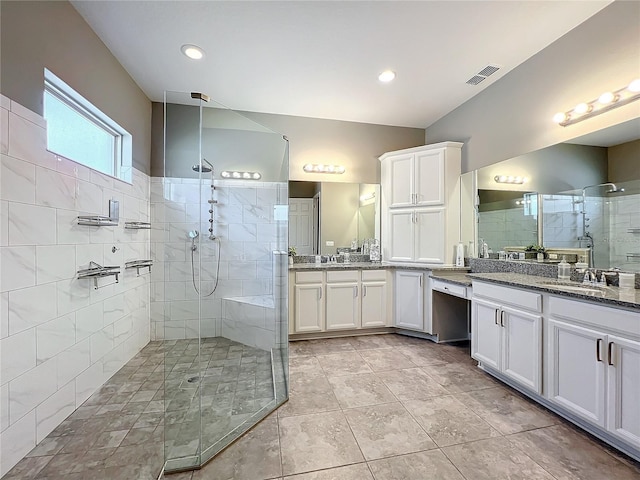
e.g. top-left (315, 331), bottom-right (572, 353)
top-left (549, 295), bottom-right (640, 338)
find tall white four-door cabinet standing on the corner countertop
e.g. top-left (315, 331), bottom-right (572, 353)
top-left (380, 142), bottom-right (462, 264)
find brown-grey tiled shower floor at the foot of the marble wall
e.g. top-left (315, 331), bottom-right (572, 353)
top-left (2, 337), bottom-right (274, 480)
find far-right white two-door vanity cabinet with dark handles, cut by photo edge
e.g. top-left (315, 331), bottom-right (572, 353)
top-left (545, 295), bottom-right (640, 448)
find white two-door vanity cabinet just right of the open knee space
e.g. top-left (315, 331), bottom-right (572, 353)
top-left (471, 281), bottom-right (542, 393)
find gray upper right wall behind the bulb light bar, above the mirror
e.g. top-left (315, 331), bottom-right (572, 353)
top-left (425, 1), bottom-right (640, 172)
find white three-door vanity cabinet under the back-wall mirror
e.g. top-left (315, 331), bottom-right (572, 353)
top-left (289, 269), bottom-right (392, 334)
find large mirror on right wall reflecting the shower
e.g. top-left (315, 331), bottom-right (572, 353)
top-left (461, 119), bottom-right (640, 272)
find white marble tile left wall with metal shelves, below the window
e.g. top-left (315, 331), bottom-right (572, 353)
top-left (0, 96), bottom-right (150, 476)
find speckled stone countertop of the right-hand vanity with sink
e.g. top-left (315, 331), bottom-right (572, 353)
top-left (468, 273), bottom-right (640, 310)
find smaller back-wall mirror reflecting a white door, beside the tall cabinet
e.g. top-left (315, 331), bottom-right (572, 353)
top-left (289, 181), bottom-right (380, 255)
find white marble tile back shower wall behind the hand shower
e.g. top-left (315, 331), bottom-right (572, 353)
top-left (151, 177), bottom-right (287, 341)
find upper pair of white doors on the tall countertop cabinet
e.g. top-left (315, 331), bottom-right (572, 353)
top-left (383, 149), bottom-right (445, 208)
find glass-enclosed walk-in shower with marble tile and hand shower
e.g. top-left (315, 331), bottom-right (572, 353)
top-left (151, 92), bottom-right (288, 472)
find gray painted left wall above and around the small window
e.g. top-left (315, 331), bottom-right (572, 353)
top-left (0, 1), bottom-right (151, 173)
